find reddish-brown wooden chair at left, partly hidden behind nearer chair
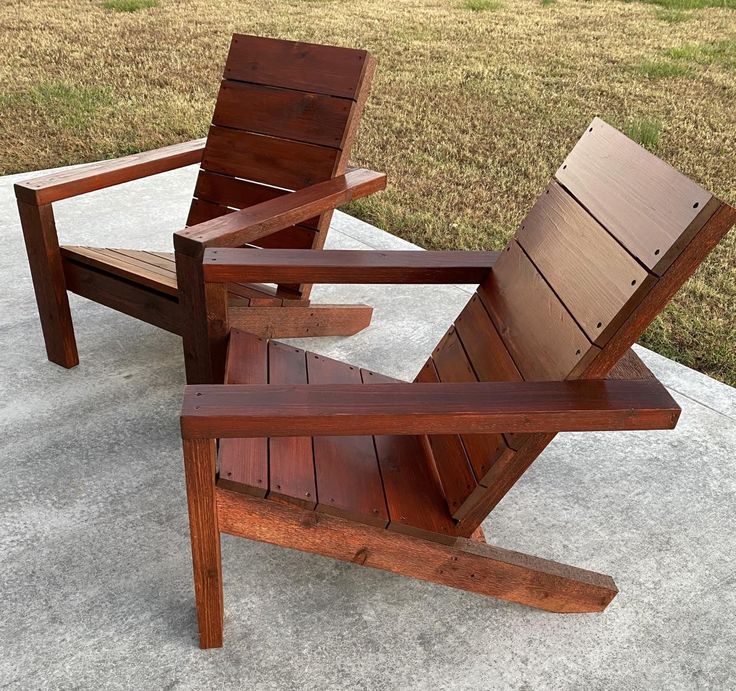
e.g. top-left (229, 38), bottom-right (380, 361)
top-left (15, 34), bottom-right (385, 383)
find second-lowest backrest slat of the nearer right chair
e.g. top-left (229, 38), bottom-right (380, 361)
top-left (432, 328), bottom-right (506, 484)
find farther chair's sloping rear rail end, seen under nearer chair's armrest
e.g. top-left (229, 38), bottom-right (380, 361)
top-left (229, 304), bottom-right (373, 338)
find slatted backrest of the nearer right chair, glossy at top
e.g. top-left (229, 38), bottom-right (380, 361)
top-left (417, 118), bottom-right (736, 532)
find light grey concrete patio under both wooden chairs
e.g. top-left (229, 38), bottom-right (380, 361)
top-left (0, 168), bottom-right (736, 690)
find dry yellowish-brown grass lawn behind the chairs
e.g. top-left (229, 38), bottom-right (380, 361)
top-left (0, 0), bottom-right (736, 384)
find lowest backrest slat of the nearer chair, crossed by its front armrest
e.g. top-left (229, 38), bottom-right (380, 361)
top-left (416, 358), bottom-right (483, 519)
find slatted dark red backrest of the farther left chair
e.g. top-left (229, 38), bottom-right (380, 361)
top-left (187, 34), bottom-right (375, 298)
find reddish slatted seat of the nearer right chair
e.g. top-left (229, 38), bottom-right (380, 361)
top-left (218, 331), bottom-right (456, 543)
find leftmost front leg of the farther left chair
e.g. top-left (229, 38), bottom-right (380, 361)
top-left (18, 200), bottom-right (79, 368)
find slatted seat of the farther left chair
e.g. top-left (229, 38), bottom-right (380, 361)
top-left (61, 245), bottom-right (284, 306)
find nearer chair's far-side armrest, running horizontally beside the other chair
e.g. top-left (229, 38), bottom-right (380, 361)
top-left (204, 249), bottom-right (501, 284)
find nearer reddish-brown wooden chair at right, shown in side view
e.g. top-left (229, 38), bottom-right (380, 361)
top-left (181, 119), bottom-right (736, 647)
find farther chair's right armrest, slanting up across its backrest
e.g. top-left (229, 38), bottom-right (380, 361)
top-left (174, 168), bottom-right (386, 258)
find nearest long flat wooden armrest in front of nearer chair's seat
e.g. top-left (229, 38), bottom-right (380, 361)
top-left (181, 379), bottom-right (680, 438)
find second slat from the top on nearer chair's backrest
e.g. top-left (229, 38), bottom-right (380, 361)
top-left (516, 182), bottom-right (657, 346)
